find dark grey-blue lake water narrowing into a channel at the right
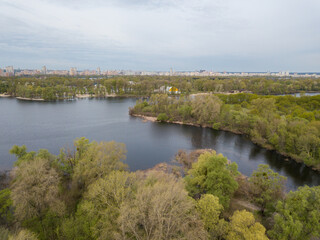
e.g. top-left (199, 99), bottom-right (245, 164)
top-left (0, 98), bottom-right (320, 189)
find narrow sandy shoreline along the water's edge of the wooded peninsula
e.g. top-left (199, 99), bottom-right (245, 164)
top-left (130, 114), bottom-right (320, 173)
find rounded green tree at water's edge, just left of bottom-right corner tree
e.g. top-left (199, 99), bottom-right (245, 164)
top-left (249, 164), bottom-right (286, 212)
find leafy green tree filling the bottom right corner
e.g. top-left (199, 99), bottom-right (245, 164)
top-left (269, 186), bottom-right (320, 240)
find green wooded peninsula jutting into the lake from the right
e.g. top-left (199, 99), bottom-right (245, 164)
top-left (130, 93), bottom-right (320, 170)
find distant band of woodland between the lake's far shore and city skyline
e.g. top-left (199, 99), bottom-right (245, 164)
top-left (0, 76), bottom-right (320, 101)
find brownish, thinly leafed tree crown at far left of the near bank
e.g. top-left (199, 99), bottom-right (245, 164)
top-left (11, 159), bottom-right (64, 221)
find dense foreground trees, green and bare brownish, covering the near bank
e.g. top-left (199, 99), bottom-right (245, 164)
top-left (0, 138), bottom-right (320, 240)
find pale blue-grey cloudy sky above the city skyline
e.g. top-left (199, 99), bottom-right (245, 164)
top-left (0, 0), bottom-right (320, 72)
